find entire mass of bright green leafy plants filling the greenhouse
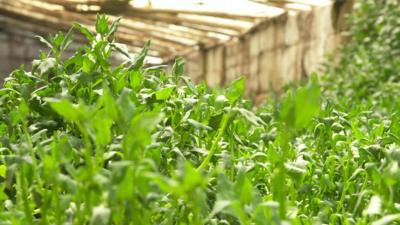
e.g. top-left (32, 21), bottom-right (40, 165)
top-left (0, 0), bottom-right (400, 225)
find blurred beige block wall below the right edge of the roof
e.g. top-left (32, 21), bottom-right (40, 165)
top-left (186, 1), bottom-right (353, 99)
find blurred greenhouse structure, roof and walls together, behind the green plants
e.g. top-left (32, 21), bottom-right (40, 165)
top-left (0, 0), bottom-right (353, 96)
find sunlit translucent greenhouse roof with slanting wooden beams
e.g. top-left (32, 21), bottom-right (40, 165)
top-left (0, 0), bottom-right (329, 62)
